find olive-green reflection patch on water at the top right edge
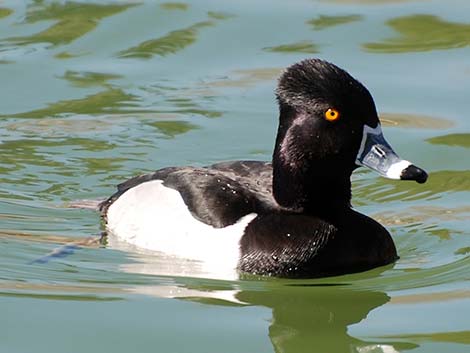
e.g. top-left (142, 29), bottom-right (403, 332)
top-left (363, 15), bottom-right (470, 53)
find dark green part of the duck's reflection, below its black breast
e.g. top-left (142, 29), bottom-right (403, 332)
top-left (237, 285), bottom-right (404, 353)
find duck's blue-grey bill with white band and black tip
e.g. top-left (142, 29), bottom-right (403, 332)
top-left (356, 124), bottom-right (428, 184)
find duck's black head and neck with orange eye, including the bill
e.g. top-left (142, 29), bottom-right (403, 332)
top-left (273, 59), bottom-right (427, 211)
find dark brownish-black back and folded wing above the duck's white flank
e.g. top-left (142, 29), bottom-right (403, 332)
top-left (100, 161), bottom-right (279, 228)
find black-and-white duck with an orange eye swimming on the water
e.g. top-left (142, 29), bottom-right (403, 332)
top-left (99, 58), bottom-right (428, 278)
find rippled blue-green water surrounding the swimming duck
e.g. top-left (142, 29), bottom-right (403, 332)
top-left (0, 0), bottom-right (470, 353)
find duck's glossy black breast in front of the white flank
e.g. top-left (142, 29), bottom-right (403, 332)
top-left (239, 209), bottom-right (398, 277)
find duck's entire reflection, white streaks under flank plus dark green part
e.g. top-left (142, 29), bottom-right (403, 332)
top-left (111, 245), bottom-right (416, 353)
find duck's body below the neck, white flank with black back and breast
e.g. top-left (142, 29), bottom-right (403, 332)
top-left (101, 161), bottom-right (396, 278)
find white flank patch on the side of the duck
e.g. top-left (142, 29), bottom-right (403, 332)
top-left (107, 180), bottom-right (256, 278)
